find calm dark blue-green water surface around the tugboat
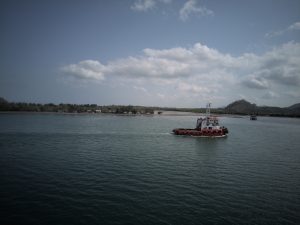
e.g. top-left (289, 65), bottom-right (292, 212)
top-left (0, 114), bottom-right (300, 224)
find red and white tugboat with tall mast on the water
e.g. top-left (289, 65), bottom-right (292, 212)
top-left (173, 103), bottom-right (228, 137)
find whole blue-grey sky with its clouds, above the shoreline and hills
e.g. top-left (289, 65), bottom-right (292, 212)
top-left (0, 0), bottom-right (300, 107)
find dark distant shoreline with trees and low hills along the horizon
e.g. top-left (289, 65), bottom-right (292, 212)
top-left (0, 97), bottom-right (300, 118)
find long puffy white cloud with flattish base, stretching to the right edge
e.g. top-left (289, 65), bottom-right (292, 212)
top-left (62, 42), bottom-right (300, 85)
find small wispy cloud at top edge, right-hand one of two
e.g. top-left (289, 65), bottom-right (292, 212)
top-left (179, 0), bottom-right (214, 21)
